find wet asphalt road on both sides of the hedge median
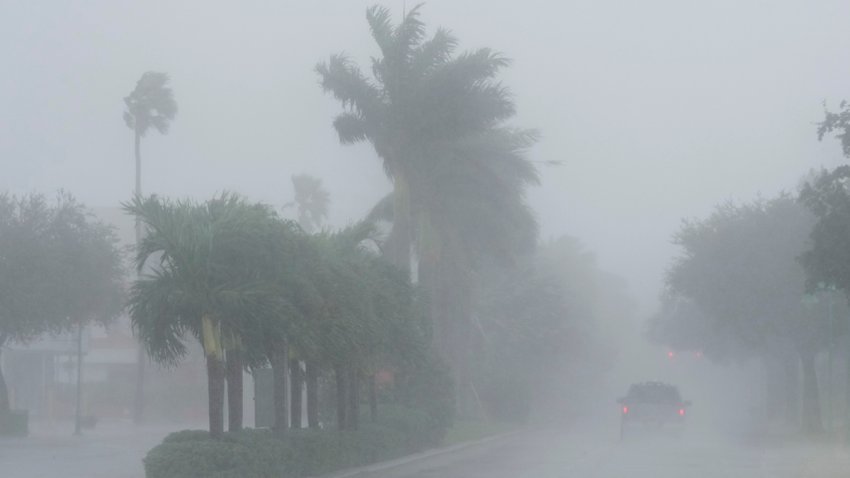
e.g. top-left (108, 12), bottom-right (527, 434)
top-left (0, 424), bottom-right (850, 478)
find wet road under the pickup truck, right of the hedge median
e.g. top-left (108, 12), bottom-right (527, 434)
top-left (362, 431), bottom-right (850, 478)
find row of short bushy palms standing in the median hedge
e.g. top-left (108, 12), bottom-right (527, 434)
top-left (125, 194), bottom-right (428, 436)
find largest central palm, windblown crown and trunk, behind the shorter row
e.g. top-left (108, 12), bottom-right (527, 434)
top-left (316, 6), bottom-right (538, 410)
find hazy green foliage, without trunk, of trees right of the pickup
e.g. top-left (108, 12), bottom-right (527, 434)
top-left (651, 195), bottom-right (836, 358)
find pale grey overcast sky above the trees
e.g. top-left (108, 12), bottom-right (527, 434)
top-left (0, 0), bottom-right (850, 314)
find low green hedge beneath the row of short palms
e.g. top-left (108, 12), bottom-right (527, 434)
top-left (144, 407), bottom-right (445, 478)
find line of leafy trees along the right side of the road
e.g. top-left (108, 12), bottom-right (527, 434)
top-left (649, 102), bottom-right (850, 434)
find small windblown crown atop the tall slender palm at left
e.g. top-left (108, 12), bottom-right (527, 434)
top-left (124, 71), bottom-right (177, 136)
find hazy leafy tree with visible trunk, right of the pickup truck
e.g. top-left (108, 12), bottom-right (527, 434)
top-left (667, 195), bottom-right (831, 432)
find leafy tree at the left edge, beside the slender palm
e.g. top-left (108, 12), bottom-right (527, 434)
top-left (0, 193), bottom-right (124, 414)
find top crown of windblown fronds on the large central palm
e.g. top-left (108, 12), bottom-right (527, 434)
top-left (316, 6), bottom-right (515, 177)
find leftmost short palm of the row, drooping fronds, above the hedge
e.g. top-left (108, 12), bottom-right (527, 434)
top-left (125, 194), bottom-right (276, 437)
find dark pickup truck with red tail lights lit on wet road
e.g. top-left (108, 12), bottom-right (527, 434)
top-left (617, 382), bottom-right (691, 439)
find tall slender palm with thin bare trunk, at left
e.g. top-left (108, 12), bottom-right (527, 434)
top-left (124, 71), bottom-right (177, 423)
